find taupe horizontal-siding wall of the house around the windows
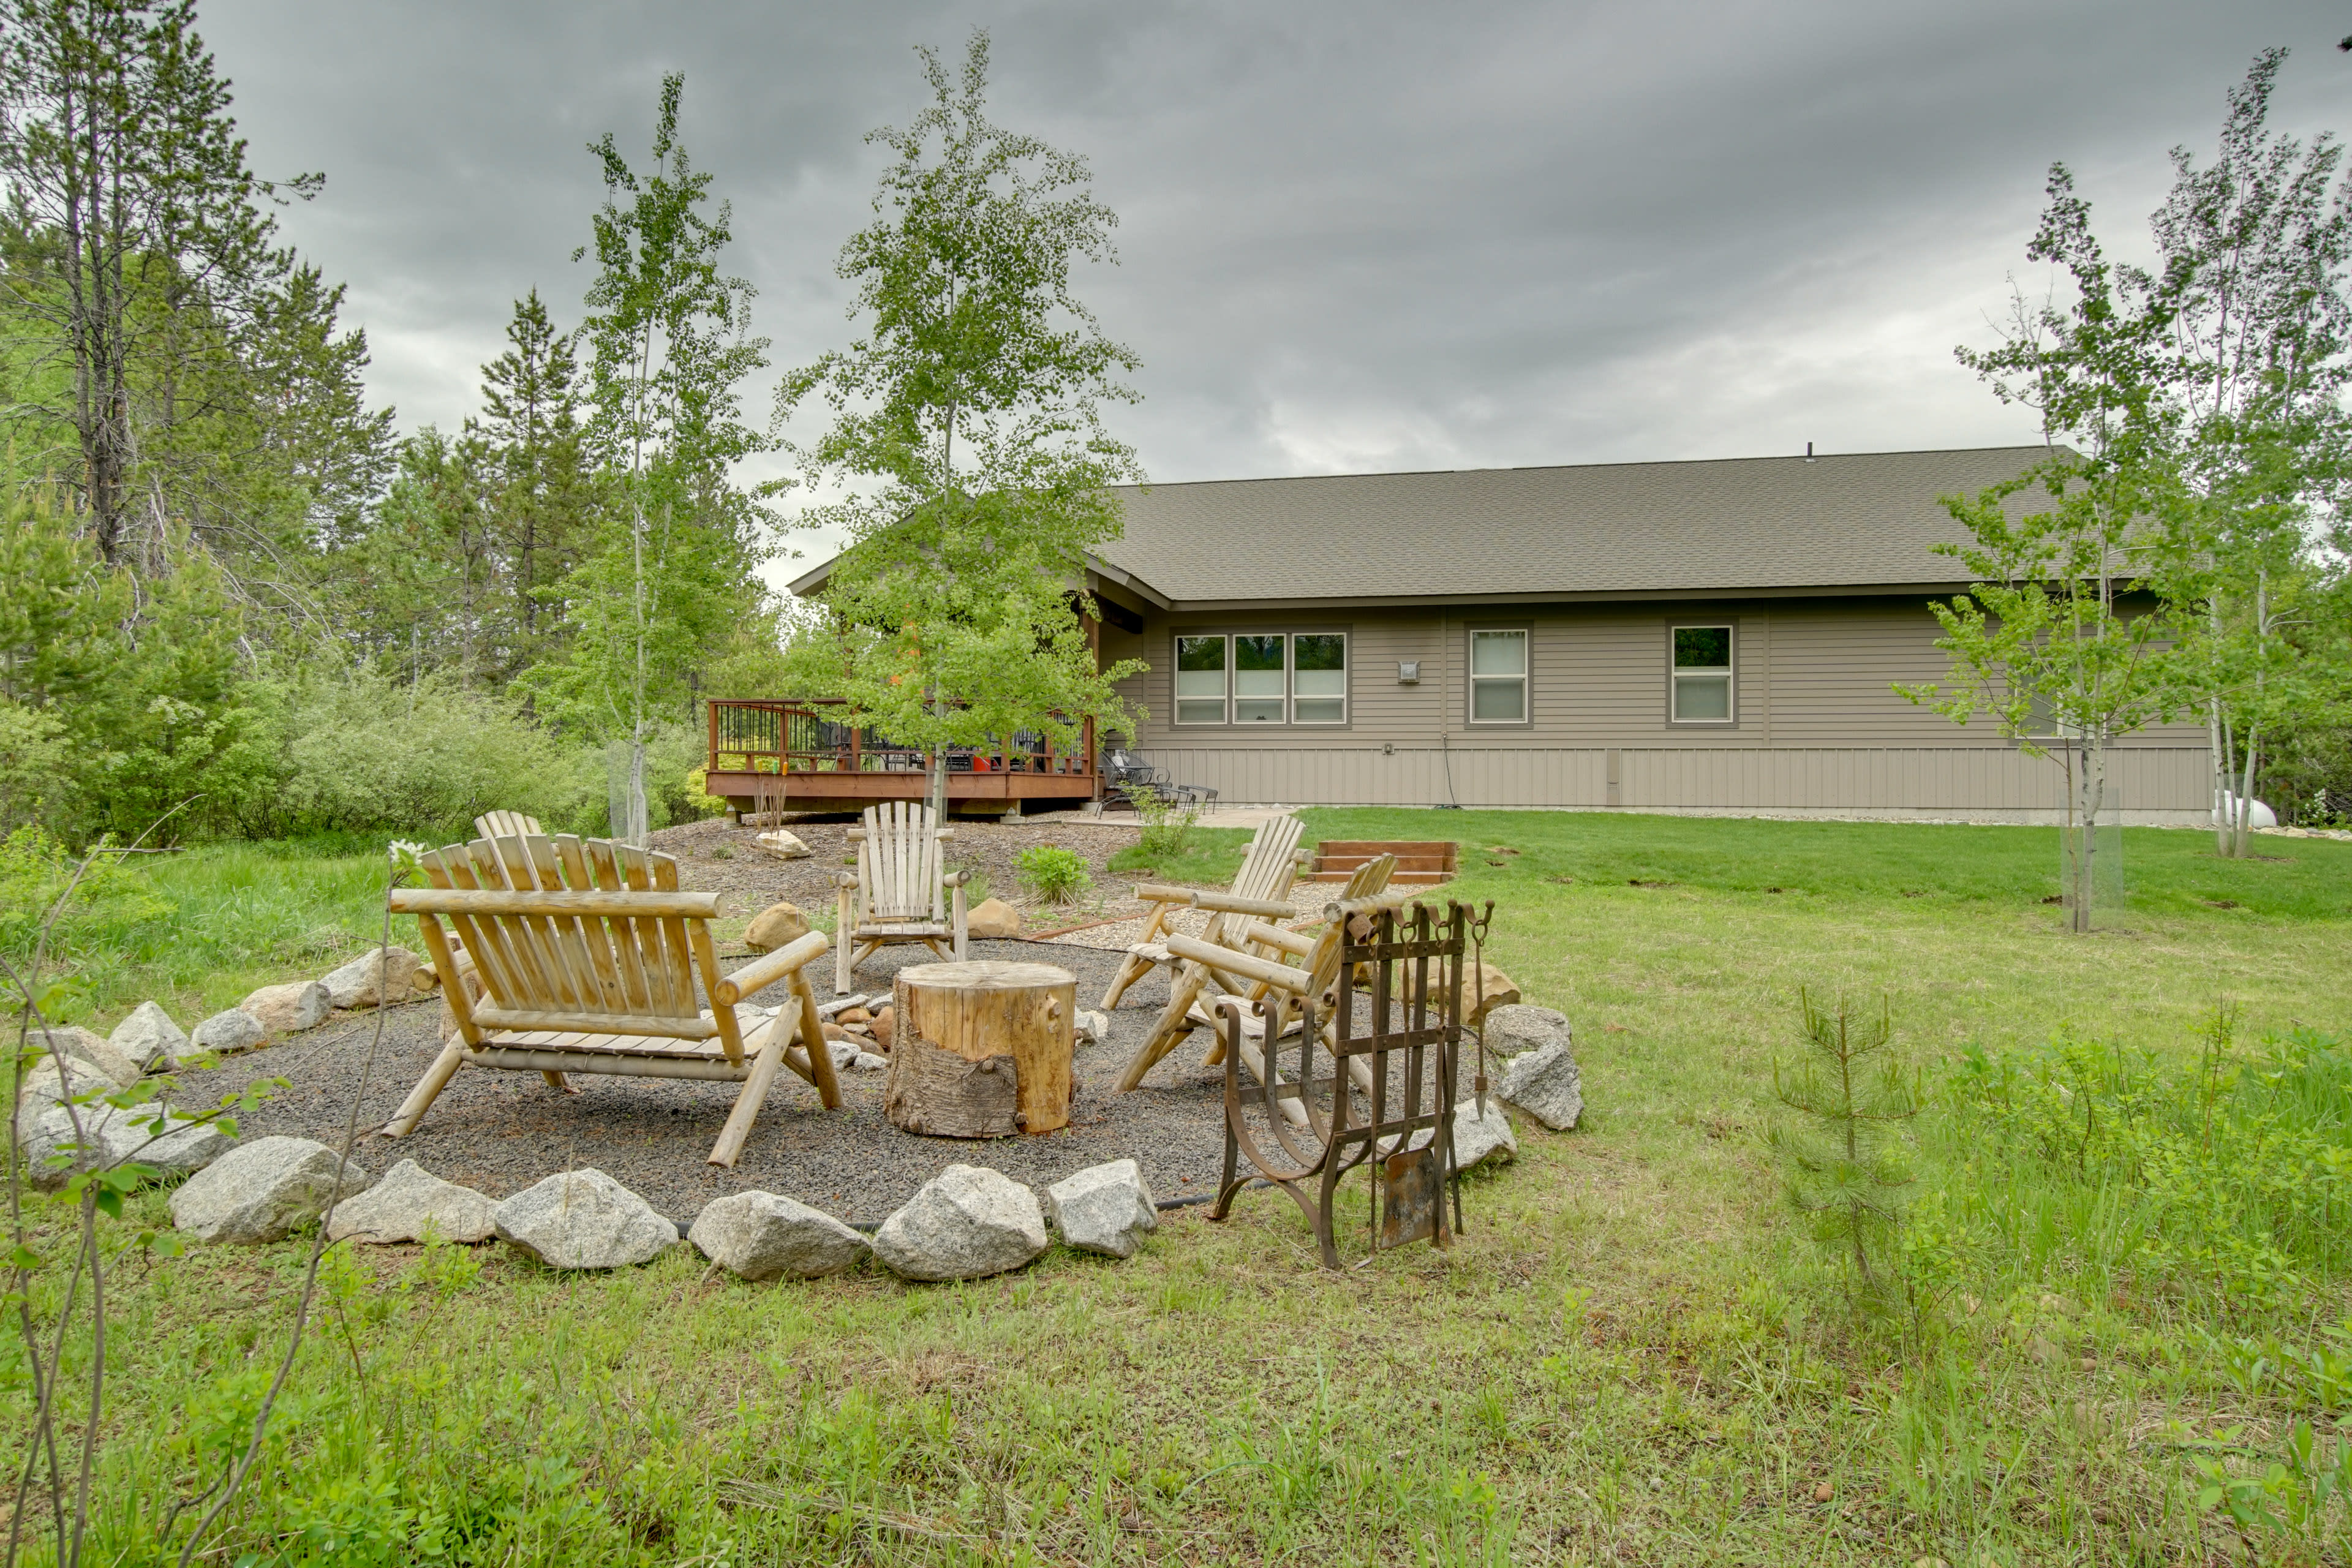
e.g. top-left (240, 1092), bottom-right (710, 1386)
top-left (1103, 600), bottom-right (2211, 823)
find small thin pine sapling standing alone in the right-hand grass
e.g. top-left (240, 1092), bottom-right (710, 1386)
top-left (1766, 992), bottom-right (1919, 1291)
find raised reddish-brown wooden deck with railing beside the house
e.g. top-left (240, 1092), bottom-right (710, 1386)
top-left (703, 701), bottom-right (1103, 816)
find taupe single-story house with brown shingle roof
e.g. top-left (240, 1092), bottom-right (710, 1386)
top-left (752, 447), bottom-right (2211, 823)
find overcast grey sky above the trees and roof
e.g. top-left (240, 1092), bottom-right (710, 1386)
top-left (200, 0), bottom-right (2352, 573)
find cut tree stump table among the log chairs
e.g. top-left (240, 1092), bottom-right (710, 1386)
top-left (882, 959), bottom-right (1077, 1138)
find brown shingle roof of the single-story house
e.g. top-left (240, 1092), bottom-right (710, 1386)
top-left (1101, 447), bottom-right (2046, 604)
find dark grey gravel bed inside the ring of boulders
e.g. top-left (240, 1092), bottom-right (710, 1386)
top-left (184, 930), bottom-right (1223, 1223)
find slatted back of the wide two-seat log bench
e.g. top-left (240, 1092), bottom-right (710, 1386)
top-left (423, 835), bottom-right (717, 1018)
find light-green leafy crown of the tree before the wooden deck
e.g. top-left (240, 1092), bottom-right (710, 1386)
top-left (776, 33), bottom-right (1143, 775)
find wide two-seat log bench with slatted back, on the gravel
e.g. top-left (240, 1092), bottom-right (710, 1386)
top-left (383, 835), bottom-right (842, 1166)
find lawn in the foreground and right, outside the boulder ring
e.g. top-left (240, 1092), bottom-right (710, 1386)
top-left (12, 811), bottom-right (2352, 1568)
